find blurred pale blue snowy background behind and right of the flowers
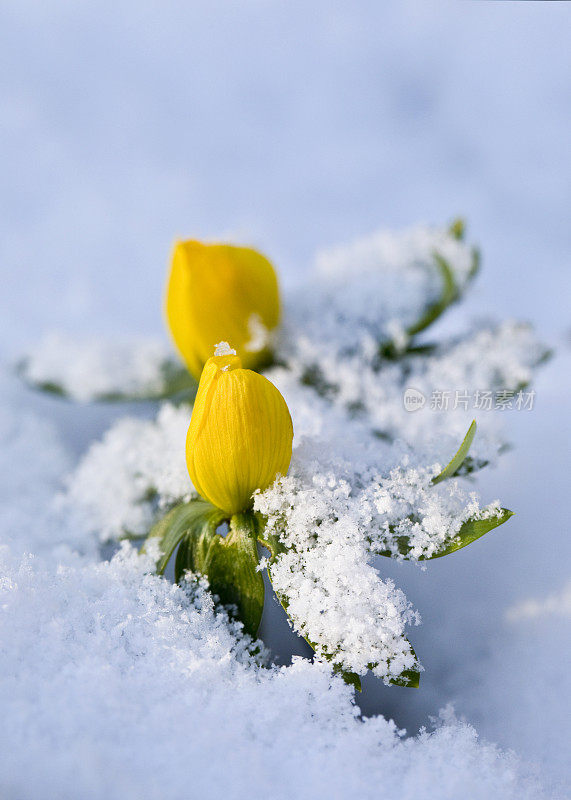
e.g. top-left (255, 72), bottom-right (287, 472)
top-left (0, 0), bottom-right (571, 792)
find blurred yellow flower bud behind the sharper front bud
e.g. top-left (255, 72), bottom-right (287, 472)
top-left (166, 241), bottom-right (280, 380)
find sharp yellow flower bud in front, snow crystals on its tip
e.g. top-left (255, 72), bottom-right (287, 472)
top-left (186, 342), bottom-right (293, 515)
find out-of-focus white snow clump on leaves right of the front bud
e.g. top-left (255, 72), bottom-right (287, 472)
top-left (277, 312), bottom-right (545, 450)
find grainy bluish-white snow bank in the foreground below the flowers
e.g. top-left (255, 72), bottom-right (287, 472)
top-left (0, 384), bottom-right (543, 800)
